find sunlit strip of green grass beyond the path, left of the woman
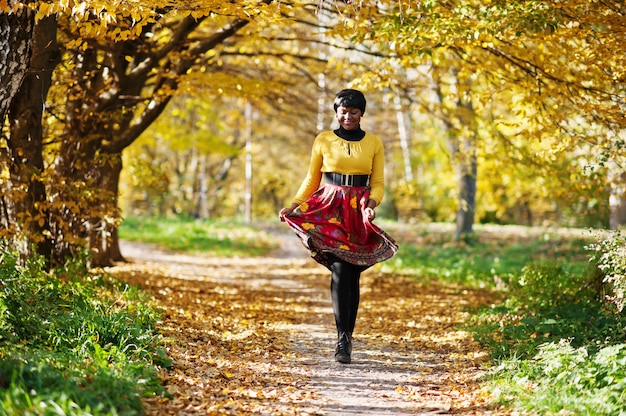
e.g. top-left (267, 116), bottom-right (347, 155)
top-left (119, 217), bottom-right (277, 257)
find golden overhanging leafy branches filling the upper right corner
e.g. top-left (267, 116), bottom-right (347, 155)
top-left (336, 0), bottom-right (626, 143)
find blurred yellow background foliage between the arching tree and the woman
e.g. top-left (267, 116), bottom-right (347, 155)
top-left (119, 4), bottom-right (360, 218)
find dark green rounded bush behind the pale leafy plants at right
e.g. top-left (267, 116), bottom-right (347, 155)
top-left (472, 262), bottom-right (626, 359)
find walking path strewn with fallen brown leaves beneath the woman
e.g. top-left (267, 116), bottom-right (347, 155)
top-left (109, 229), bottom-right (504, 416)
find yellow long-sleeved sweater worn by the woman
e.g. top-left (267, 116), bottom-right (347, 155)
top-left (293, 131), bottom-right (385, 205)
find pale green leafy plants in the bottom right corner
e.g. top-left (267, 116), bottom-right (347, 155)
top-left (491, 340), bottom-right (626, 415)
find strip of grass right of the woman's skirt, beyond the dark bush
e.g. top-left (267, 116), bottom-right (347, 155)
top-left (383, 224), bottom-right (589, 287)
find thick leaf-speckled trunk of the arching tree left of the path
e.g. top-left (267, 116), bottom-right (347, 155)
top-left (50, 39), bottom-right (141, 266)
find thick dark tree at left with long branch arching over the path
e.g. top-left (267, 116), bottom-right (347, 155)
top-left (3, 1), bottom-right (332, 264)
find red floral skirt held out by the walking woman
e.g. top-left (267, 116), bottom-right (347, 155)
top-left (285, 185), bottom-right (398, 270)
